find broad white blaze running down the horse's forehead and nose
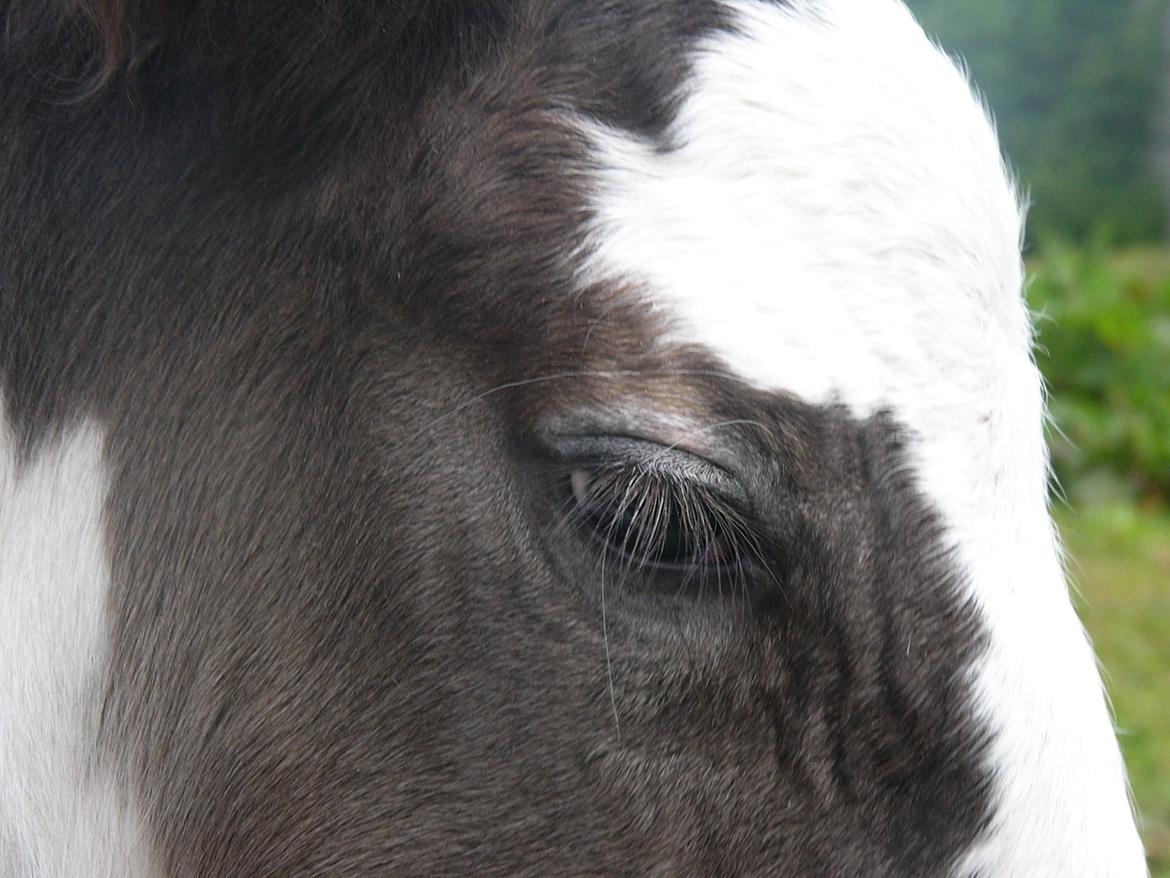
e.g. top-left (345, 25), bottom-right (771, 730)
top-left (579, 0), bottom-right (1145, 876)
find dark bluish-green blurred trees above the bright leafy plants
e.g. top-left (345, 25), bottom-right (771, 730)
top-left (909, 0), bottom-right (1166, 241)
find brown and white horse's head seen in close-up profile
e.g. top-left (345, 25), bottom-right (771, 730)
top-left (0, 0), bottom-right (1145, 878)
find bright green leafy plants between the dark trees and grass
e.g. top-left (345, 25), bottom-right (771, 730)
top-left (1028, 243), bottom-right (1170, 506)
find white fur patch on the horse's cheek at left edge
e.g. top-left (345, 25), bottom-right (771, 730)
top-left (0, 400), bottom-right (156, 878)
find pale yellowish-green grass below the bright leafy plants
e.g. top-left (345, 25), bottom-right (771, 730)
top-left (1058, 506), bottom-right (1170, 878)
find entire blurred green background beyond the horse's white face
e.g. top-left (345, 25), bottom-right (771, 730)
top-left (908, 0), bottom-right (1170, 878)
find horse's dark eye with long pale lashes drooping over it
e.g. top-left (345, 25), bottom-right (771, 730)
top-left (569, 465), bottom-right (746, 570)
